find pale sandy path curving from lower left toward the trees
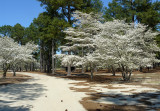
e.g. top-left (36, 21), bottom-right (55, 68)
top-left (0, 72), bottom-right (86, 111)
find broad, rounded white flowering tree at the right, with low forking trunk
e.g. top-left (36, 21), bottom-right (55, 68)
top-left (94, 20), bottom-right (160, 81)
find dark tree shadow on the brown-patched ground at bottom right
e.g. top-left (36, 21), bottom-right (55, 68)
top-left (89, 91), bottom-right (160, 111)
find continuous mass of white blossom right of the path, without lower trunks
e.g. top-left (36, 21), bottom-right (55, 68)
top-left (57, 11), bottom-right (160, 80)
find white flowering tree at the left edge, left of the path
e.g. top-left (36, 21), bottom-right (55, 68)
top-left (0, 37), bottom-right (37, 77)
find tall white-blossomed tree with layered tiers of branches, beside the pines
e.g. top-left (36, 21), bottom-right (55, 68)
top-left (57, 11), bottom-right (101, 75)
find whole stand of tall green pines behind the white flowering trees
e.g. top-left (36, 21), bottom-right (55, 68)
top-left (0, 0), bottom-right (160, 80)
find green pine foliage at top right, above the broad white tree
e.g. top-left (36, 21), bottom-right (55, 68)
top-left (104, 0), bottom-right (160, 30)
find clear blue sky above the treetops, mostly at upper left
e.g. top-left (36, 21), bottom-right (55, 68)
top-left (0, 0), bottom-right (112, 27)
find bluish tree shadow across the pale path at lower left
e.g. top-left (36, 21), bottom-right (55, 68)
top-left (0, 82), bottom-right (46, 111)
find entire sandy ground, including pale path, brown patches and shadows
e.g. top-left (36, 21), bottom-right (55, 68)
top-left (0, 72), bottom-right (160, 111)
